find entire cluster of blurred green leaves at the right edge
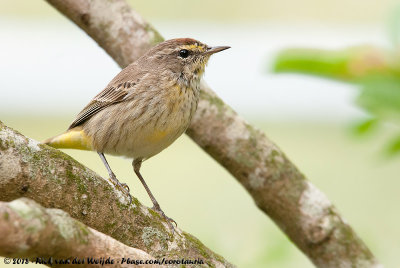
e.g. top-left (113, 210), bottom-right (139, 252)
top-left (274, 11), bottom-right (400, 155)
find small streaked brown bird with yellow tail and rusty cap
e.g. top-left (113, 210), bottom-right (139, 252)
top-left (44, 38), bottom-right (229, 229)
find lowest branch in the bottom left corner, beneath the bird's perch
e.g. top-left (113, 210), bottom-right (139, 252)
top-left (0, 198), bottom-right (158, 267)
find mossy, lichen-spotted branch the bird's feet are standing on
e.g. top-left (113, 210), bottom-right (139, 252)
top-left (0, 122), bottom-right (232, 267)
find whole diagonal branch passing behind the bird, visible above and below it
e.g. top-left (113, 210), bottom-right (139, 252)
top-left (38, 0), bottom-right (377, 267)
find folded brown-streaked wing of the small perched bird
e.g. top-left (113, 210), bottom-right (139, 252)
top-left (68, 81), bottom-right (136, 129)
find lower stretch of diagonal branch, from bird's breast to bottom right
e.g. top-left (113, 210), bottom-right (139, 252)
top-left (187, 86), bottom-right (381, 268)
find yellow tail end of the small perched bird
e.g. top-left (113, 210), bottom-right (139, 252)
top-left (42, 127), bottom-right (93, 151)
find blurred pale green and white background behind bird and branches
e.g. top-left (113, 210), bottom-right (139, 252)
top-left (0, 0), bottom-right (400, 267)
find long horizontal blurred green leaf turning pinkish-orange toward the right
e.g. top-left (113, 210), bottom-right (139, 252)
top-left (274, 45), bottom-right (400, 82)
